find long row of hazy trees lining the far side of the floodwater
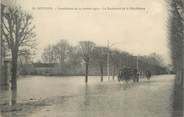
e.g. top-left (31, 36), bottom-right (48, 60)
top-left (30, 40), bottom-right (166, 82)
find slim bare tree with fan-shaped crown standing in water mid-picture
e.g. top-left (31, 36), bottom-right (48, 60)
top-left (79, 41), bottom-right (96, 83)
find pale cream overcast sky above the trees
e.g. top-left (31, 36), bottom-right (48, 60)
top-left (12, 0), bottom-right (170, 63)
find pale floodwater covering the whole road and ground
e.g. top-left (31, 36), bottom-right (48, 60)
top-left (0, 75), bottom-right (183, 117)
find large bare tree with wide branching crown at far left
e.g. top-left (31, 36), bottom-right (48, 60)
top-left (1, 6), bottom-right (36, 89)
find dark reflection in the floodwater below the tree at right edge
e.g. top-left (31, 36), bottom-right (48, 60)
top-left (172, 86), bottom-right (184, 117)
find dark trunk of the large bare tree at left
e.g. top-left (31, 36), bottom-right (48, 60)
top-left (11, 50), bottom-right (18, 90)
